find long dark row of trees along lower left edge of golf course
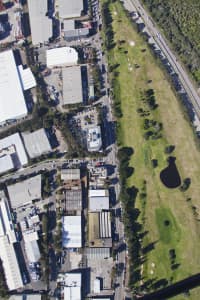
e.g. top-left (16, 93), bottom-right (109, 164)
top-left (118, 147), bottom-right (142, 288)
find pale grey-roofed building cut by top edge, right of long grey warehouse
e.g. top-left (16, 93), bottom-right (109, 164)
top-left (59, 0), bottom-right (83, 19)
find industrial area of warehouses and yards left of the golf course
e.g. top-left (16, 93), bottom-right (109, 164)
top-left (0, 0), bottom-right (126, 300)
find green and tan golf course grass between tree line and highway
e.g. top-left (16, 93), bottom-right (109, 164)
top-left (102, 0), bottom-right (200, 300)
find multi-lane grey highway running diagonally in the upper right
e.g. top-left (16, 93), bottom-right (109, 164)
top-left (124, 0), bottom-right (200, 119)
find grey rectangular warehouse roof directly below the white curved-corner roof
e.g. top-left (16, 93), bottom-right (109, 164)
top-left (62, 66), bottom-right (83, 105)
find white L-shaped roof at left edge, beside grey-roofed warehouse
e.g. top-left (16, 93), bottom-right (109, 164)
top-left (0, 133), bottom-right (28, 168)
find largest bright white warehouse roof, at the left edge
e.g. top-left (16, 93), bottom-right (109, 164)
top-left (0, 50), bottom-right (28, 123)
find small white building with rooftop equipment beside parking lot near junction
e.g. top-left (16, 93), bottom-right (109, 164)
top-left (87, 126), bottom-right (102, 152)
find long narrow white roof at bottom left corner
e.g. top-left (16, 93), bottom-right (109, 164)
top-left (0, 236), bottom-right (23, 291)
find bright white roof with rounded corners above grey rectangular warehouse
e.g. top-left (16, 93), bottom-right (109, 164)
top-left (46, 47), bottom-right (78, 68)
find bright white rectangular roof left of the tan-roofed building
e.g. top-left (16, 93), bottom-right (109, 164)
top-left (62, 216), bottom-right (82, 248)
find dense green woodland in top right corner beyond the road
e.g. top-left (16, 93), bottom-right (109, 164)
top-left (143, 0), bottom-right (200, 83)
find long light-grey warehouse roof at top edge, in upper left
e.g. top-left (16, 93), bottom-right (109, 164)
top-left (28, 0), bottom-right (53, 45)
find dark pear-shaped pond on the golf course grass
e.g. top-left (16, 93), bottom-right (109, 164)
top-left (160, 156), bottom-right (181, 189)
